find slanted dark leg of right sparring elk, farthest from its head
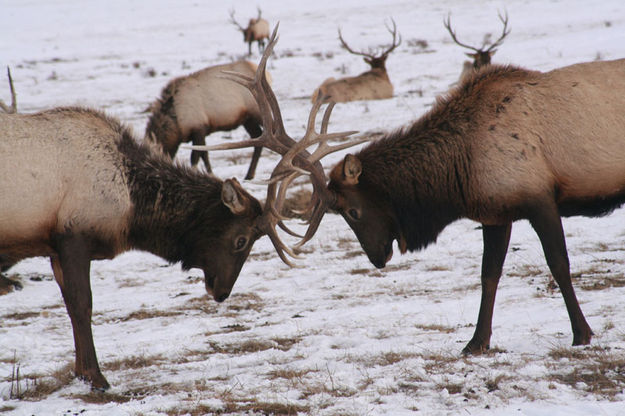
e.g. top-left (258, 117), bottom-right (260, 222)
top-left (530, 204), bottom-right (593, 345)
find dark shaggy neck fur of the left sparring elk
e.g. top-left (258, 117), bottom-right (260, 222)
top-left (119, 135), bottom-right (233, 268)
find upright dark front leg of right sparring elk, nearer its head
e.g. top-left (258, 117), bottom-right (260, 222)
top-left (462, 224), bottom-right (512, 355)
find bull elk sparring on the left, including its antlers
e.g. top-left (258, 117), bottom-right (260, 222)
top-left (0, 27), bottom-right (360, 390)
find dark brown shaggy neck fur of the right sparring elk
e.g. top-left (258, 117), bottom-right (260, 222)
top-left (357, 66), bottom-right (523, 250)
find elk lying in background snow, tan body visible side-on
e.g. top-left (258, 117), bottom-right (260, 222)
top-left (311, 21), bottom-right (401, 103)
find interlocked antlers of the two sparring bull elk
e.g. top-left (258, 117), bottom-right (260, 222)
top-left (188, 25), bottom-right (366, 266)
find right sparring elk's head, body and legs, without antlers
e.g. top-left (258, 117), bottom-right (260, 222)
top-left (327, 59), bottom-right (625, 353)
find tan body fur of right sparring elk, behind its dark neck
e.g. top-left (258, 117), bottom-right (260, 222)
top-left (467, 60), bottom-right (625, 223)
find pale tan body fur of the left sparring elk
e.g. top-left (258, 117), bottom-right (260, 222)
top-left (0, 112), bottom-right (132, 258)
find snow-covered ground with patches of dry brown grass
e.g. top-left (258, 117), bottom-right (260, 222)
top-left (0, 0), bottom-right (625, 416)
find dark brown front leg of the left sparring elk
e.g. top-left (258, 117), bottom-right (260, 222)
top-left (51, 236), bottom-right (110, 390)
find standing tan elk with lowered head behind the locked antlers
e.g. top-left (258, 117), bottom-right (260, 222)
top-left (145, 61), bottom-right (270, 179)
